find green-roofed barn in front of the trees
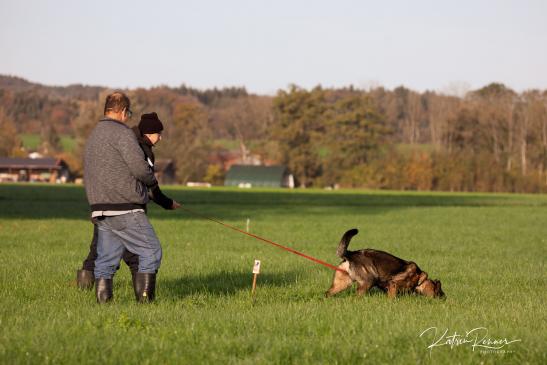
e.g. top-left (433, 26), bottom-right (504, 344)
top-left (224, 165), bottom-right (294, 188)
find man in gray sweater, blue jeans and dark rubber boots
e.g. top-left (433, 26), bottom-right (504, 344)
top-left (84, 92), bottom-right (162, 303)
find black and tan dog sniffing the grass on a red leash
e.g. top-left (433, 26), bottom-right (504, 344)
top-left (326, 229), bottom-right (445, 298)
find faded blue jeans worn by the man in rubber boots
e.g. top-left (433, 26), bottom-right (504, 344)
top-left (95, 212), bottom-right (162, 279)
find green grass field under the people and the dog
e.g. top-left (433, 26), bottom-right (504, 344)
top-left (0, 185), bottom-right (547, 364)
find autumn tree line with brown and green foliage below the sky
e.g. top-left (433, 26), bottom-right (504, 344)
top-left (0, 76), bottom-right (547, 193)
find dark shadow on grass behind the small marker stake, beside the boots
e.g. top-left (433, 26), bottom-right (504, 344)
top-left (158, 271), bottom-right (301, 299)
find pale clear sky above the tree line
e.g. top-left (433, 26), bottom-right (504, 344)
top-left (0, 0), bottom-right (547, 94)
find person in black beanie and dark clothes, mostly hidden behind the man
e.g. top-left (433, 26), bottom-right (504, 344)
top-left (76, 113), bottom-right (180, 296)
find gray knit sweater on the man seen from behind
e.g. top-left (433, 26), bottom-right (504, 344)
top-left (84, 119), bottom-right (158, 211)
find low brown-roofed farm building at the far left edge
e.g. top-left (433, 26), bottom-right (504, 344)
top-left (0, 157), bottom-right (70, 183)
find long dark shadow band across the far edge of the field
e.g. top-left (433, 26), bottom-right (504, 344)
top-left (0, 184), bottom-right (547, 220)
